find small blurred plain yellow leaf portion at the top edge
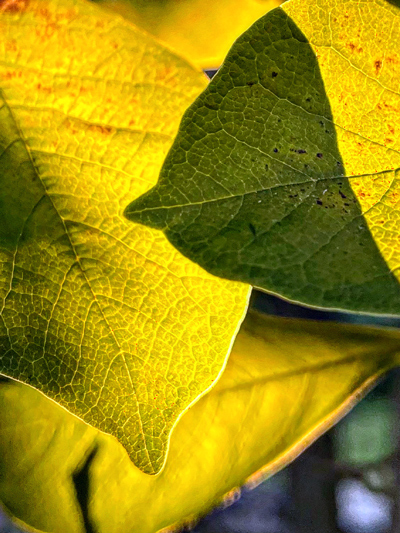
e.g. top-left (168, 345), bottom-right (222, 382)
top-left (93, 0), bottom-right (281, 68)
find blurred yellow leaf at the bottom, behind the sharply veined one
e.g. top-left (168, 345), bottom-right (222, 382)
top-left (0, 312), bottom-right (400, 533)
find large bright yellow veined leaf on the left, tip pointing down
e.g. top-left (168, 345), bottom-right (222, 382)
top-left (0, 0), bottom-right (248, 473)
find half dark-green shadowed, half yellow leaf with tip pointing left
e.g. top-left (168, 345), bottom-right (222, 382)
top-left (127, 0), bottom-right (400, 315)
